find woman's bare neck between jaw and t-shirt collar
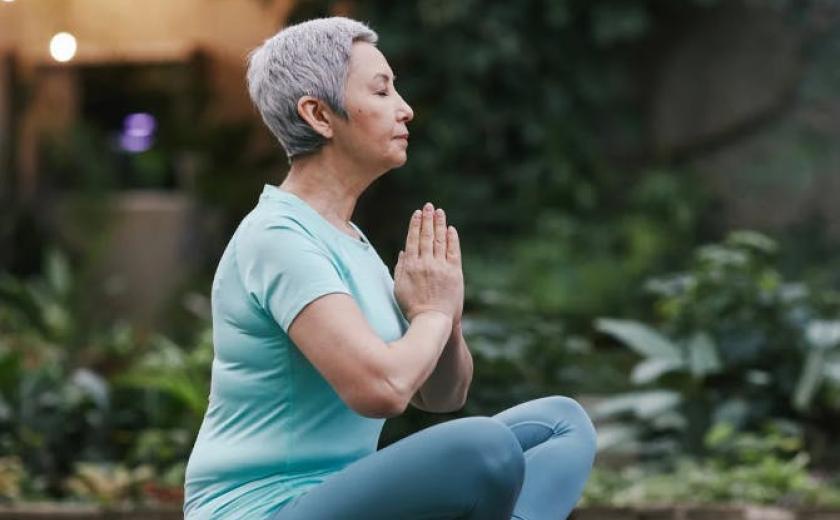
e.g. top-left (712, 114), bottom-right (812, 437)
top-left (280, 147), bottom-right (378, 228)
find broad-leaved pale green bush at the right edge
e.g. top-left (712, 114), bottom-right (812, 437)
top-left (594, 231), bottom-right (840, 460)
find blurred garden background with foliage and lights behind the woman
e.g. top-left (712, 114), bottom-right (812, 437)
top-left (0, 0), bottom-right (840, 506)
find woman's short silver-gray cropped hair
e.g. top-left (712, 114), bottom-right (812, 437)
top-left (247, 17), bottom-right (379, 162)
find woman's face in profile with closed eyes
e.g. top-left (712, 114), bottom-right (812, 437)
top-left (333, 42), bottom-right (414, 172)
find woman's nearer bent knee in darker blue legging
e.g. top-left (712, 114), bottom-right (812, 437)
top-left (442, 417), bottom-right (525, 496)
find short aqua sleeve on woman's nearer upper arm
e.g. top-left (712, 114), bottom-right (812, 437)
top-left (236, 223), bottom-right (350, 333)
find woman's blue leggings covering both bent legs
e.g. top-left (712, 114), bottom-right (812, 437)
top-left (274, 396), bottom-right (596, 520)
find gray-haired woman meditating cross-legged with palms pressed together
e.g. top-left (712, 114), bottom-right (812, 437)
top-left (184, 18), bottom-right (595, 520)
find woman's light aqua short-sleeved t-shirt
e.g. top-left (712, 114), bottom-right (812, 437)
top-left (184, 185), bottom-right (408, 519)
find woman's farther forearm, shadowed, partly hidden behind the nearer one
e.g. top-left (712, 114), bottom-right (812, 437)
top-left (420, 324), bottom-right (473, 413)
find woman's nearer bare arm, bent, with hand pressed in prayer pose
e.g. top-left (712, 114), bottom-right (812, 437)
top-left (289, 204), bottom-right (472, 417)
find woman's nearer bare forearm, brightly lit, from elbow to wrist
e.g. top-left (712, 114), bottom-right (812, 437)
top-left (384, 312), bottom-right (453, 406)
